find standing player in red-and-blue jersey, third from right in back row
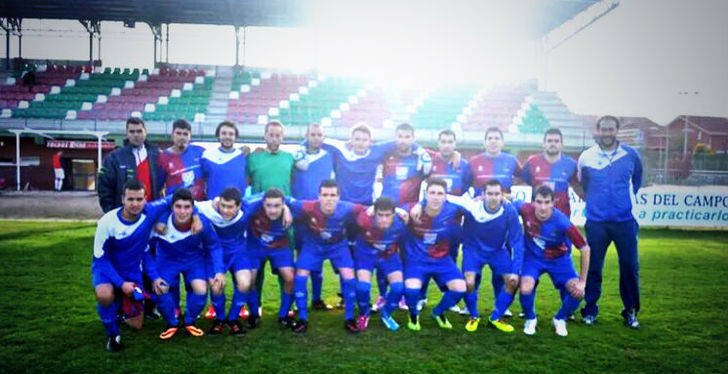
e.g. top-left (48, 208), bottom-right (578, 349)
top-left (470, 127), bottom-right (521, 317)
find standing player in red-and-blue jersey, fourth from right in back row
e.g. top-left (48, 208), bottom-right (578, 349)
top-left (417, 129), bottom-right (473, 310)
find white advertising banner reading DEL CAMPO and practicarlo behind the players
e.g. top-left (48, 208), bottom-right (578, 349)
top-left (511, 186), bottom-right (728, 229)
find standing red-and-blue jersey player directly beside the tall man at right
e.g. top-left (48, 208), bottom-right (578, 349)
top-left (519, 128), bottom-right (584, 217)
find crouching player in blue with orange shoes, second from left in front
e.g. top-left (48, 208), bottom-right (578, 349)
top-left (145, 188), bottom-right (225, 340)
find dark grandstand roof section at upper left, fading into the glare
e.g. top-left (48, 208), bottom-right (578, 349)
top-left (0, 0), bottom-right (305, 27)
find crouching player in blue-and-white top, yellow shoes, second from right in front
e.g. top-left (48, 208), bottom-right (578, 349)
top-left (448, 179), bottom-right (523, 332)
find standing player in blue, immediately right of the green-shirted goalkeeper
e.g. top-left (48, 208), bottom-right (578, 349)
top-left (291, 123), bottom-right (335, 310)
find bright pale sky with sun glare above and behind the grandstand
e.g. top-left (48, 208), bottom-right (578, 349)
top-left (0, 0), bottom-right (728, 124)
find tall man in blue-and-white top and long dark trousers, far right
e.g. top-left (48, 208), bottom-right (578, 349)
top-left (578, 116), bottom-right (642, 328)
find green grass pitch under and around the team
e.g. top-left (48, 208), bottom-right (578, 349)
top-left (0, 221), bottom-right (728, 374)
